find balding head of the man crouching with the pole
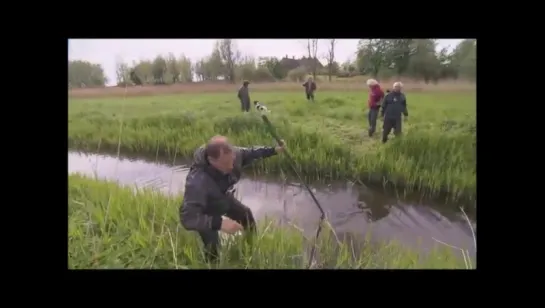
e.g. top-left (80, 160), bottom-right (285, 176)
top-left (204, 136), bottom-right (235, 173)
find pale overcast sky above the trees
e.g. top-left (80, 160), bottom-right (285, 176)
top-left (68, 39), bottom-right (461, 84)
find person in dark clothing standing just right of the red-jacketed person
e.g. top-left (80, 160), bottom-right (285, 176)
top-left (382, 81), bottom-right (409, 143)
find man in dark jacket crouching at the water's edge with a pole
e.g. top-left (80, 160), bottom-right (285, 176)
top-left (180, 136), bottom-right (284, 262)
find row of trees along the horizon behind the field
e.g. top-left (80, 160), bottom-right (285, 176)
top-left (68, 39), bottom-right (477, 87)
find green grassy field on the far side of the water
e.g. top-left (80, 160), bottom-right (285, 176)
top-left (68, 92), bottom-right (476, 199)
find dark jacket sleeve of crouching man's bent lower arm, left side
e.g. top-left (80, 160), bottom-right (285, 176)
top-left (180, 175), bottom-right (222, 231)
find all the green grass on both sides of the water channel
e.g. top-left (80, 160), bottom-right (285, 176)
top-left (68, 85), bottom-right (476, 269)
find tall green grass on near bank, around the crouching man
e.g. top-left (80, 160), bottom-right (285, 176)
top-left (68, 175), bottom-right (475, 269)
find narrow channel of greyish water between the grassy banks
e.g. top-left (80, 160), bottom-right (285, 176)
top-left (68, 151), bottom-right (477, 257)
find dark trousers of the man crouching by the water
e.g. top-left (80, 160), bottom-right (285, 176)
top-left (199, 196), bottom-right (256, 262)
